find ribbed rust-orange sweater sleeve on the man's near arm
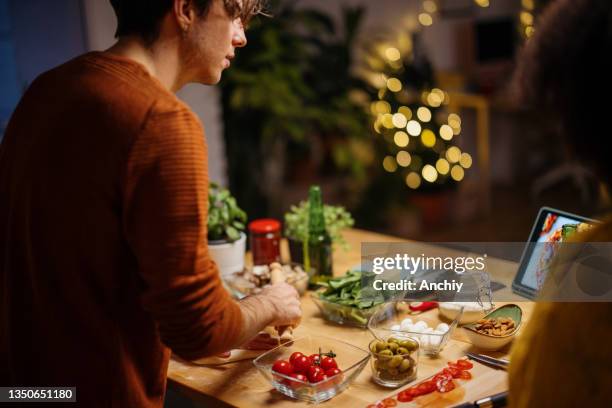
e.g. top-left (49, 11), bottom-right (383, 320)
top-left (123, 105), bottom-right (242, 359)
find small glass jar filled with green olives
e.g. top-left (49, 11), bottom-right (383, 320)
top-left (369, 336), bottom-right (419, 388)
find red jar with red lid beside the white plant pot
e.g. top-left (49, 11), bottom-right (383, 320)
top-left (249, 218), bottom-right (281, 265)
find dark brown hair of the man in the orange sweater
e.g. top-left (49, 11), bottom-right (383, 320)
top-left (110, 0), bottom-right (264, 45)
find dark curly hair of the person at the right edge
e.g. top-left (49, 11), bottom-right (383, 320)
top-left (514, 0), bottom-right (612, 184)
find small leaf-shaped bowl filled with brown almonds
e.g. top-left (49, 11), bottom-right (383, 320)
top-left (463, 304), bottom-right (523, 350)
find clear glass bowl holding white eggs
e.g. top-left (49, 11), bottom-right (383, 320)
top-left (368, 301), bottom-right (463, 356)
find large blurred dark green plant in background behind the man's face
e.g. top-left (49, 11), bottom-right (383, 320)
top-left (221, 0), bottom-right (374, 217)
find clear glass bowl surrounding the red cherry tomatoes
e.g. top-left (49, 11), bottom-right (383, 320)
top-left (253, 335), bottom-right (370, 403)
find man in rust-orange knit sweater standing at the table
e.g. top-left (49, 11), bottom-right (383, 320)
top-left (0, 0), bottom-right (301, 407)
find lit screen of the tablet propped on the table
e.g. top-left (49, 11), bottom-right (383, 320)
top-left (520, 209), bottom-right (592, 291)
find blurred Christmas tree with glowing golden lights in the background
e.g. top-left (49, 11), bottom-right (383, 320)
top-left (367, 34), bottom-right (472, 191)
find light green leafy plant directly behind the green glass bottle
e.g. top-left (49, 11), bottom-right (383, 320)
top-left (285, 201), bottom-right (355, 249)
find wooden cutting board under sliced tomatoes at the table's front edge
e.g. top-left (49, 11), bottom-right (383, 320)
top-left (372, 360), bottom-right (508, 408)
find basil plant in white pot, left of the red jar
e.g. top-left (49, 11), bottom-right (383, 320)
top-left (208, 183), bottom-right (247, 277)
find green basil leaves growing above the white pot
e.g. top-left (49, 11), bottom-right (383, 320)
top-left (208, 183), bottom-right (247, 242)
